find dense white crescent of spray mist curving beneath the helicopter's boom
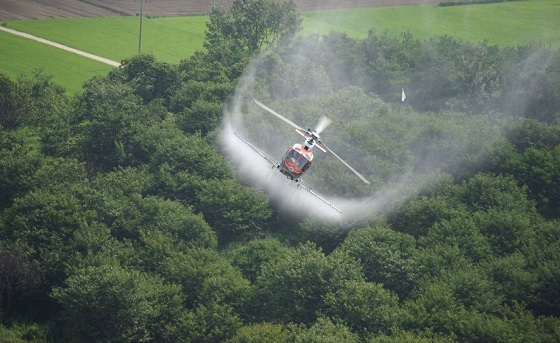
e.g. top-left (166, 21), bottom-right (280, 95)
top-left (220, 51), bottom-right (434, 225)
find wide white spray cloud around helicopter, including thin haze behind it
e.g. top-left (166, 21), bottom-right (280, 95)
top-left (221, 4), bottom-right (552, 228)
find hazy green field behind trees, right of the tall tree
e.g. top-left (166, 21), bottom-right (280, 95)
top-left (302, 0), bottom-right (560, 49)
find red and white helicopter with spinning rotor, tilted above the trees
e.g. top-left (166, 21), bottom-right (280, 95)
top-left (249, 99), bottom-right (369, 184)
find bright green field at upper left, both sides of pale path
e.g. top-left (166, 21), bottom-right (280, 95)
top-left (0, 16), bottom-right (208, 92)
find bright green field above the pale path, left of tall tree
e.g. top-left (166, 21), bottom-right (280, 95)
top-left (4, 16), bottom-right (208, 63)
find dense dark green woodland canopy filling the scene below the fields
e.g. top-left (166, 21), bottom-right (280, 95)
top-left (0, 0), bottom-right (560, 342)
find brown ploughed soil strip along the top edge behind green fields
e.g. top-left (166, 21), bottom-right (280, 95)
top-left (0, 0), bottom-right (449, 21)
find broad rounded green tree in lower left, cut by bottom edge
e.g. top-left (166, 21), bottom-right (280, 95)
top-left (52, 264), bottom-right (183, 342)
